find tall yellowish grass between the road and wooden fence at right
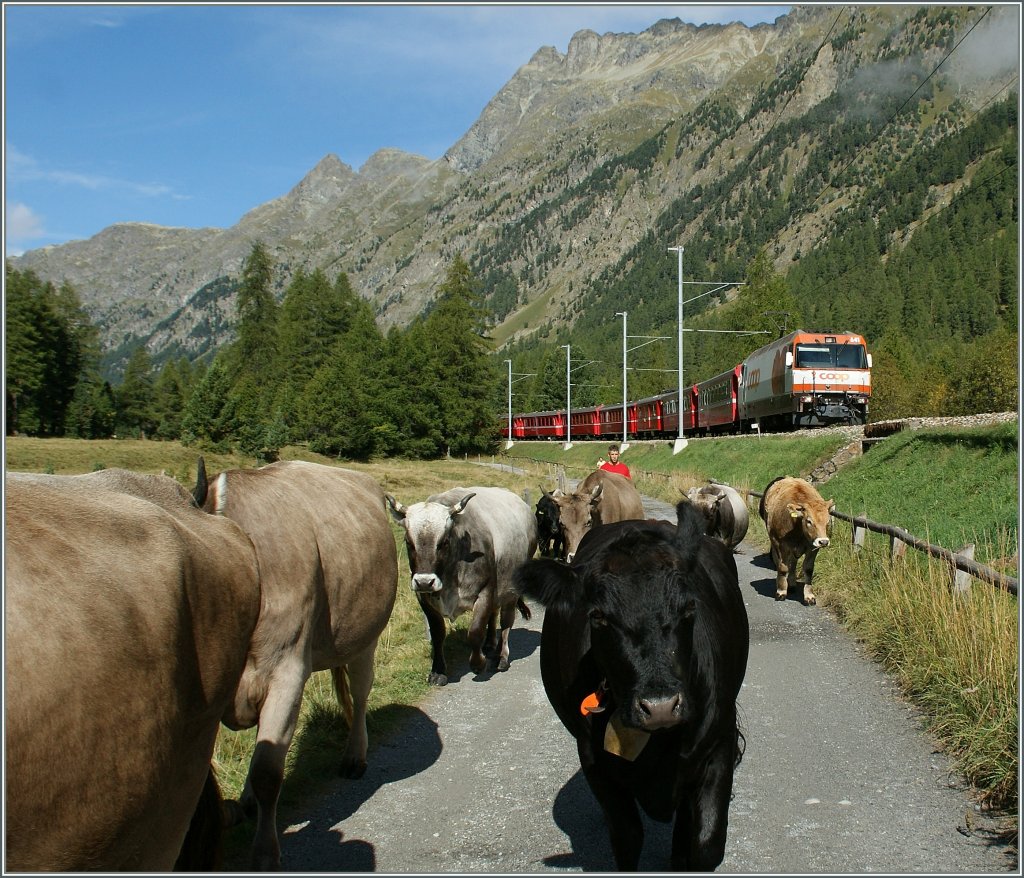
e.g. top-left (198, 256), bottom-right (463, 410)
top-left (815, 528), bottom-right (1020, 810)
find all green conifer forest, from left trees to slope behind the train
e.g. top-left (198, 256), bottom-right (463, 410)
top-left (5, 89), bottom-right (1019, 460)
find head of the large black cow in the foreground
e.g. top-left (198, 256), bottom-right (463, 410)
top-left (515, 501), bottom-right (707, 731)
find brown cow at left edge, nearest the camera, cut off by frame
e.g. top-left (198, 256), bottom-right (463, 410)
top-left (4, 470), bottom-right (260, 872)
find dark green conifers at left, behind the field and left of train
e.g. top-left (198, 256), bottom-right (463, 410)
top-left (6, 247), bottom-right (501, 460)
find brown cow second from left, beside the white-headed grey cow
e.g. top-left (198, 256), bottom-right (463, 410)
top-left (197, 460), bottom-right (398, 870)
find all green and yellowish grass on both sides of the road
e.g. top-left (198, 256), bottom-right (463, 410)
top-left (6, 424), bottom-right (1019, 845)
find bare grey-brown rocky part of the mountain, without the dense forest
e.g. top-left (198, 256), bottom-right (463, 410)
top-left (9, 7), bottom-right (1015, 373)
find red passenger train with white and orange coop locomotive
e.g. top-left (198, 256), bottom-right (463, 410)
top-left (502, 330), bottom-right (871, 442)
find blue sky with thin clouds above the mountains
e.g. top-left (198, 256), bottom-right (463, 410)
top-left (3, 3), bottom-right (790, 255)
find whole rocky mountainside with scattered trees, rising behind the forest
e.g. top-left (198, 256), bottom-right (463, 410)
top-left (11, 6), bottom-right (1016, 381)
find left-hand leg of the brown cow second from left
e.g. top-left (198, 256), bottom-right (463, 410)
top-left (242, 661), bottom-right (311, 872)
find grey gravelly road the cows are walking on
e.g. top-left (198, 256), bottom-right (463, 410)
top-left (232, 493), bottom-right (1017, 874)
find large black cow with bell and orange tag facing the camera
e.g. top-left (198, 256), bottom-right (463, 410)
top-left (516, 502), bottom-right (750, 871)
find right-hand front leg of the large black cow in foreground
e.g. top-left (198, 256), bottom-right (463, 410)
top-left (670, 738), bottom-right (736, 872)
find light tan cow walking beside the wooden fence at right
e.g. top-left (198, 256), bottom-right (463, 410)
top-left (758, 476), bottom-right (836, 605)
